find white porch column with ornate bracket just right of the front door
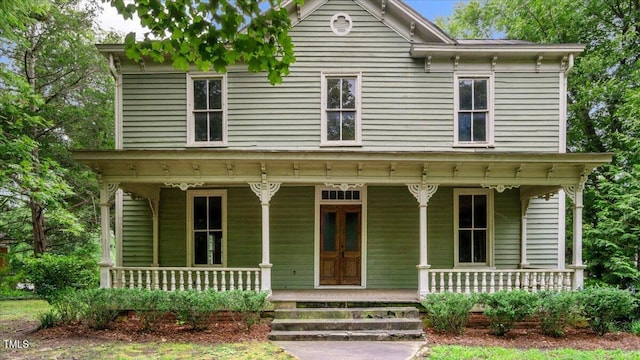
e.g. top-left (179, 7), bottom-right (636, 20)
top-left (407, 181), bottom-right (438, 299)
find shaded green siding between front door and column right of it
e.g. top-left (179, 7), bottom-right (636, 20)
top-left (367, 186), bottom-right (420, 289)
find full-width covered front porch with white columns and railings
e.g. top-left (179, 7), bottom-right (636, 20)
top-left (75, 150), bottom-right (610, 299)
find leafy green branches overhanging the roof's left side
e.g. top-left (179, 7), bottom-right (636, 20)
top-left (105, 0), bottom-right (302, 84)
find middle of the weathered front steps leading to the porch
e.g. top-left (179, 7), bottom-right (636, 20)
top-left (271, 318), bottom-right (422, 331)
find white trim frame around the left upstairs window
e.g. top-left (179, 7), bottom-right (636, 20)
top-left (186, 73), bottom-right (228, 147)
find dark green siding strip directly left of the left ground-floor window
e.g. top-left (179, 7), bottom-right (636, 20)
top-left (158, 189), bottom-right (187, 266)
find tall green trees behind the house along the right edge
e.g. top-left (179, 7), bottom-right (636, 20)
top-left (438, 0), bottom-right (640, 286)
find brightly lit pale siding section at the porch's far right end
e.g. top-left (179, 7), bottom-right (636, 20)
top-left (527, 195), bottom-right (558, 267)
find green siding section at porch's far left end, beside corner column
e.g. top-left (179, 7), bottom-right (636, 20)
top-left (122, 196), bottom-right (153, 266)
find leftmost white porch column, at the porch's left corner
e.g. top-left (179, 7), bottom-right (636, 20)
top-left (98, 183), bottom-right (118, 288)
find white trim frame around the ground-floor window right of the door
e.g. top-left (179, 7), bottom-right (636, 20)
top-left (453, 188), bottom-right (495, 268)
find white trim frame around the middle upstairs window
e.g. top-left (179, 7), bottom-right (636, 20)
top-left (320, 72), bottom-right (362, 146)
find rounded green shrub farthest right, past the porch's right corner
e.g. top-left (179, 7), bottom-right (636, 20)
top-left (578, 287), bottom-right (637, 336)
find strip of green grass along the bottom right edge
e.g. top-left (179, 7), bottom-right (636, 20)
top-left (429, 345), bottom-right (640, 360)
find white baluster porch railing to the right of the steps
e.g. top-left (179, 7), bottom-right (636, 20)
top-left (429, 269), bottom-right (573, 294)
